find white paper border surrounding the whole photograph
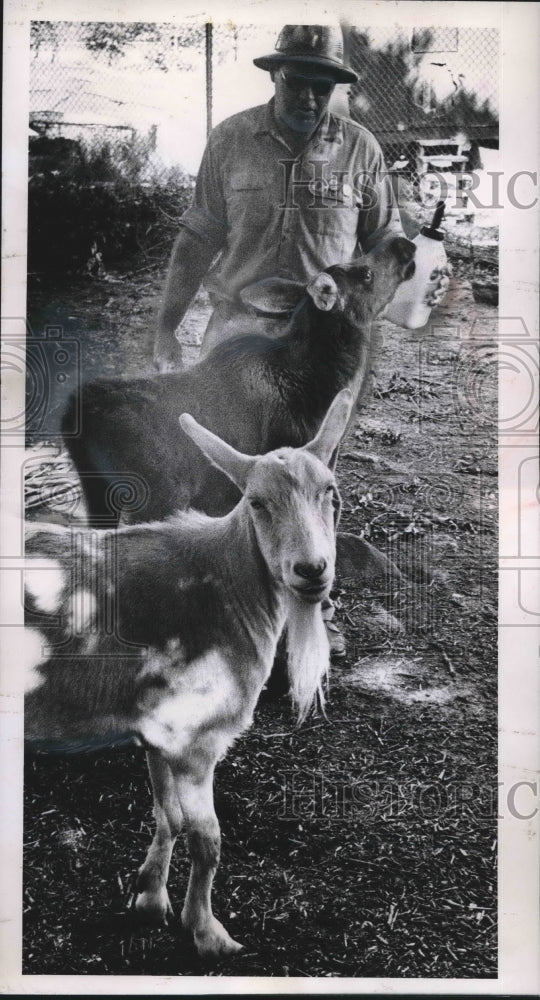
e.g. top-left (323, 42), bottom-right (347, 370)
top-left (0, 0), bottom-right (540, 995)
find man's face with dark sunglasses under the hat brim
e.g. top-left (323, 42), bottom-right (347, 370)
top-left (272, 63), bottom-right (336, 133)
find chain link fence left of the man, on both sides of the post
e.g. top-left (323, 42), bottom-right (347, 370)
top-left (29, 21), bottom-right (277, 183)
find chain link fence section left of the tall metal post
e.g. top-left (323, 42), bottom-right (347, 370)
top-left (30, 21), bottom-right (205, 183)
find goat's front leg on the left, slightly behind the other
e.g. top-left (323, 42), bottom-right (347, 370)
top-left (135, 750), bottom-right (183, 923)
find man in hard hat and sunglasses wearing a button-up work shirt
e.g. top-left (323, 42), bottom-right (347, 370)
top-left (154, 24), bottom-right (448, 658)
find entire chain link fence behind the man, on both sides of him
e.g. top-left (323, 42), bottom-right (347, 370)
top-left (30, 21), bottom-right (499, 178)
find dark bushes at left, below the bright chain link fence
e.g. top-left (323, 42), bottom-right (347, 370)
top-left (28, 136), bottom-right (192, 274)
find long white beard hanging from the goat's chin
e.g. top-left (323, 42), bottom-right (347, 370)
top-left (286, 593), bottom-right (330, 725)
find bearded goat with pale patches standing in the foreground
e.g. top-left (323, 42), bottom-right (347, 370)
top-left (25, 390), bottom-right (352, 957)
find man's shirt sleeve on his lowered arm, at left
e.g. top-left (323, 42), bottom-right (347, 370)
top-left (180, 136), bottom-right (227, 253)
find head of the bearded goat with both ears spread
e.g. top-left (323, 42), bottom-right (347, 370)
top-left (180, 389), bottom-right (352, 604)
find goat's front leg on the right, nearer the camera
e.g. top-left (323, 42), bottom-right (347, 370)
top-left (173, 763), bottom-right (242, 958)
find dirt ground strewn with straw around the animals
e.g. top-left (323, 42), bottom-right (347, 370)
top-left (24, 258), bottom-right (497, 978)
